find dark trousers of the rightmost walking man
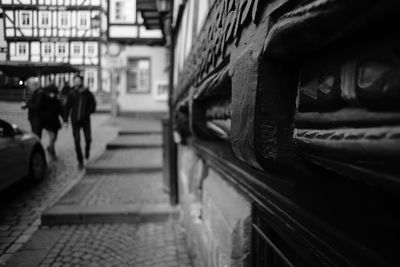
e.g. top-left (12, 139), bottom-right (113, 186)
top-left (72, 119), bottom-right (92, 163)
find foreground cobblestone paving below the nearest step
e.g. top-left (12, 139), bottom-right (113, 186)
top-left (39, 222), bottom-right (191, 267)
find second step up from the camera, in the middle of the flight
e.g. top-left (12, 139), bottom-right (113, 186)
top-left (86, 148), bottom-right (162, 174)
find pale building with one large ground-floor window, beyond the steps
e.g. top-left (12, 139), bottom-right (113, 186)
top-left (108, 0), bottom-right (169, 114)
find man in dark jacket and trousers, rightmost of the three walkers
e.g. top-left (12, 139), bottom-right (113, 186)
top-left (64, 75), bottom-right (96, 169)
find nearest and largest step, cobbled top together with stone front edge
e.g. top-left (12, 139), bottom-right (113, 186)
top-left (41, 173), bottom-right (179, 226)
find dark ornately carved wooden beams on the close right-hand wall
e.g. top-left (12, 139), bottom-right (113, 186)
top-left (173, 0), bottom-right (400, 183)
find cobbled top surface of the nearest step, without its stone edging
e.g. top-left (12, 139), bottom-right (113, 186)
top-left (81, 173), bottom-right (169, 206)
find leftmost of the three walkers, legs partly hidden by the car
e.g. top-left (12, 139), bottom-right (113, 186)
top-left (21, 77), bottom-right (46, 139)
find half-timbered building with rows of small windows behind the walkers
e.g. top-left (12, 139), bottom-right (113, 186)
top-left (1, 0), bottom-right (107, 91)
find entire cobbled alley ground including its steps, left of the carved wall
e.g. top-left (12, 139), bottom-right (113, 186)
top-left (0, 105), bottom-right (191, 267)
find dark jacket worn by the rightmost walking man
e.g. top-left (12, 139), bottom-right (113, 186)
top-left (64, 88), bottom-right (96, 123)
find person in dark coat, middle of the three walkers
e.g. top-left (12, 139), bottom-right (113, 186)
top-left (43, 83), bottom-right (64, 160)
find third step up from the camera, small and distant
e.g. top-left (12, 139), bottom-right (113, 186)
top-left (107, 134), bottom-right (162, 150)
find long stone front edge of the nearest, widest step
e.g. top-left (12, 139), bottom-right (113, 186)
top-left (41, 204), bottom-right (179, 226)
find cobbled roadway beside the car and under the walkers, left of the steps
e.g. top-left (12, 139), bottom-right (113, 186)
top-left (0, 102), bottom-right (116, 265)
